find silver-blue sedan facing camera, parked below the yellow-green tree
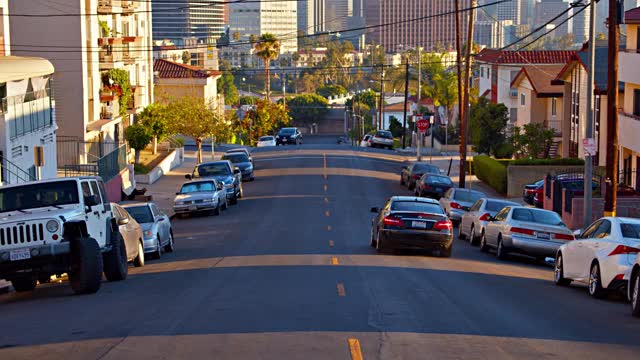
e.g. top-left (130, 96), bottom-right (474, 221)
top-left (173, 179), bottom-right (229, 215)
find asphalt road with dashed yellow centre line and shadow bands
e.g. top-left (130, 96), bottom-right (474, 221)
top-left (0, 144), bottom-right (640, 360)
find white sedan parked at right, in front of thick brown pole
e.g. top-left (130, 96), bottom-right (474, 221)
top-left (554, 217), bottom-right (640, 298)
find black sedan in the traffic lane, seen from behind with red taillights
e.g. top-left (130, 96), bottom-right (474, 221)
top-left (371, 196), bottom-right (453, 257)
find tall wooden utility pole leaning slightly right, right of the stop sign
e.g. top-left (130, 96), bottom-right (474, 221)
top-left (458, 0), bottom-right (478, 188)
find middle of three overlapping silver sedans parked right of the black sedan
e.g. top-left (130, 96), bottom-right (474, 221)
top-left (458, 198), bottom-right (519, 245)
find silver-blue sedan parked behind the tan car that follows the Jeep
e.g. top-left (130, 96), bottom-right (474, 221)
top-left (122, 202), bottom-right (175, 259)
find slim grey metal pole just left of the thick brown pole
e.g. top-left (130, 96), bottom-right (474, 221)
top-left (584, 1), bottom-right (596, 225)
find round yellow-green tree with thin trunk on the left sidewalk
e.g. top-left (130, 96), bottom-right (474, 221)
top-left (167, 96), bottom-right (226, 163)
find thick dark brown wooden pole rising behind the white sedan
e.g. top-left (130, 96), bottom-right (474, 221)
top-left (604, 0), bottom-right (619, 216)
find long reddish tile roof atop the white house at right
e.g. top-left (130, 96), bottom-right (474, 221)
top-left (476, 48), bottom-right (576, 65)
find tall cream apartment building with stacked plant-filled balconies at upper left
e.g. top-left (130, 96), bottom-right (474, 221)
top-left (10, 0), bottom-right (153, 170)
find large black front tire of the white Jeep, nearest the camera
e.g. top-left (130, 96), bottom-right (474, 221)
top-left (69, 237), bottom-right (103, 294)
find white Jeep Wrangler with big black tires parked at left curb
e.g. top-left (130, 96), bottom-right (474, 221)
top-left (0, 177), bottom-right (128, 294)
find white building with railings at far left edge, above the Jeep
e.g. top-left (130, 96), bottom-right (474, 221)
top-left (0, 0), bottom-right (57, 185)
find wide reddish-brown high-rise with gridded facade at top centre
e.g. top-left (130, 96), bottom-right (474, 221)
top-left (373, 0), bottom-right (470, 52)
